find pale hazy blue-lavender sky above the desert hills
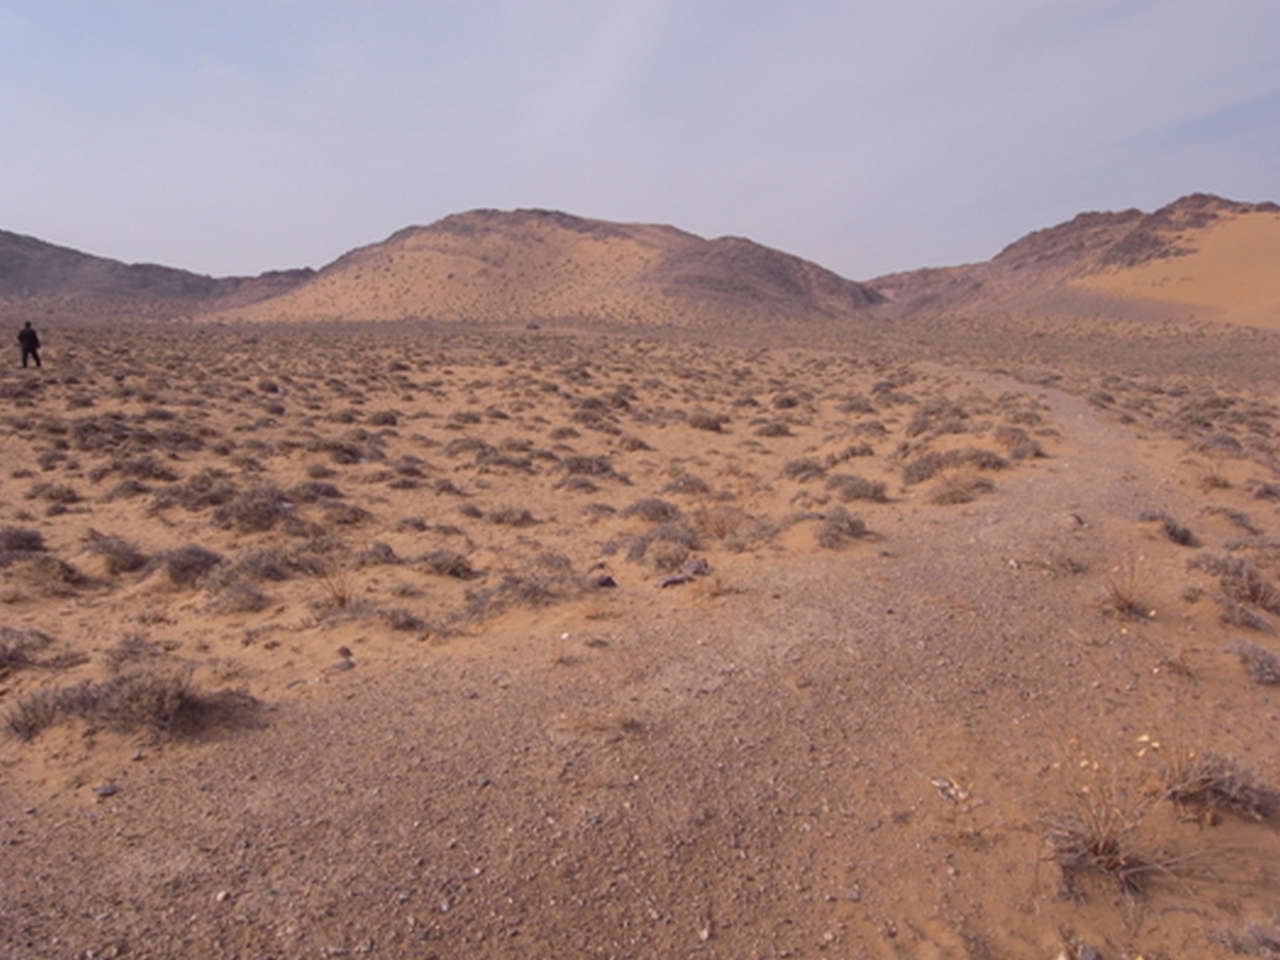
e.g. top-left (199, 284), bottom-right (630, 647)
top-left (0, 0), bottom-right (1280, 279)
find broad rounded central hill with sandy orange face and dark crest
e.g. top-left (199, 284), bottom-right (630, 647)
top-left (209, 210), bottom-right (882, 326)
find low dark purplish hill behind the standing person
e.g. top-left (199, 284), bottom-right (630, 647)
top-left (0, 230), bottom-right (312, 317)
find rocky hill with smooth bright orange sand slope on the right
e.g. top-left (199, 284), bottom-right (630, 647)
top-left (869, 193), bottom-right (1280, 325)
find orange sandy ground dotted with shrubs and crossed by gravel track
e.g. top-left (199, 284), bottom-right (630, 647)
top-left (0, 328), bottom-right (1280, 960)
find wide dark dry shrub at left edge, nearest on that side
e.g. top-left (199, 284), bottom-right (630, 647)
top-left (6, 671), bottom-right (257, 740)
